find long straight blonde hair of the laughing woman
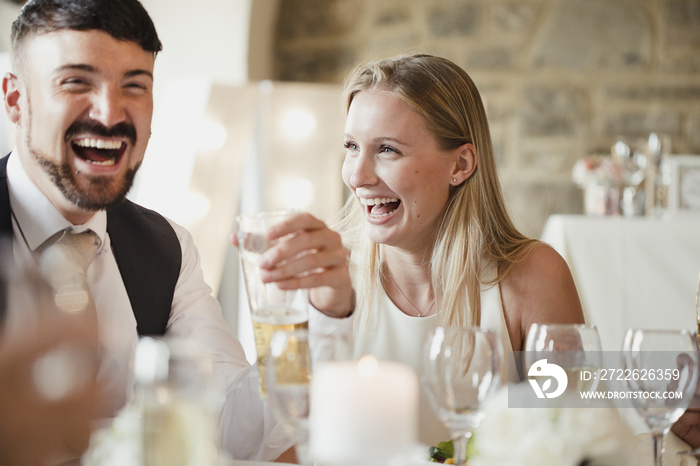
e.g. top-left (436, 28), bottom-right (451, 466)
top-left (335, 54), bottom-right (537, 326)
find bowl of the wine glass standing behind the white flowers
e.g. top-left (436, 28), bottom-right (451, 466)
top-left (523, 323), bottom-right (602, 397)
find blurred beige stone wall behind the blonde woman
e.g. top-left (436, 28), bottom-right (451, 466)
top-left (274, 0), bottom-right (700, 236)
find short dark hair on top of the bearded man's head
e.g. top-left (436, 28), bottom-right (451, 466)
top-left (12, 0), bottom-right (163, 63)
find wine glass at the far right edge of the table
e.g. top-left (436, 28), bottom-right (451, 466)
top-left (622, 329), bottom-right (698, 466)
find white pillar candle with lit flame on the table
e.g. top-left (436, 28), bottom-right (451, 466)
top-left (309, 356), bottom-right (418, 465)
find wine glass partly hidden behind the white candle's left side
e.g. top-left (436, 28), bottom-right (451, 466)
top-left (265, 329), bottom-right (350, 466)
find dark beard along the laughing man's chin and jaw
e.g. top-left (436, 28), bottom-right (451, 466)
top-left (26, 105), bottom-right (141, 211)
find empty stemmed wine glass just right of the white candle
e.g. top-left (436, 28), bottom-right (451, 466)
top-left (421, 327), bottom-right (503, 466)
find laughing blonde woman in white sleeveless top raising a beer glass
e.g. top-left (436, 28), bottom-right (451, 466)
top-left (246, 55), bottom-right (583, 443)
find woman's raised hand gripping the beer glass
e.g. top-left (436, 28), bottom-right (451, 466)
top-left (232, 213), bottom-right (354, 318)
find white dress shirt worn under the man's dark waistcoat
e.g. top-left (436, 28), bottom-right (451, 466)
top-left (5, 154), bottom-right (292, 460)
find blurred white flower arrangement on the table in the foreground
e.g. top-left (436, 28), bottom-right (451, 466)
top-left (469, 384), bottom-right (639, 466)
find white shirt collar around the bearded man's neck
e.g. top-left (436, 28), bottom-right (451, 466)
top-left (7, 151), bottom-right (107, 253)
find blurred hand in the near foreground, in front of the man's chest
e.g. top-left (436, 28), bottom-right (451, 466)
top-left (0, 321), bottom-right (98, 466)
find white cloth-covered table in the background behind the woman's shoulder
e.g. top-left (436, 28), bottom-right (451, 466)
top-left (542, 215), bottom-right (700, 351)
